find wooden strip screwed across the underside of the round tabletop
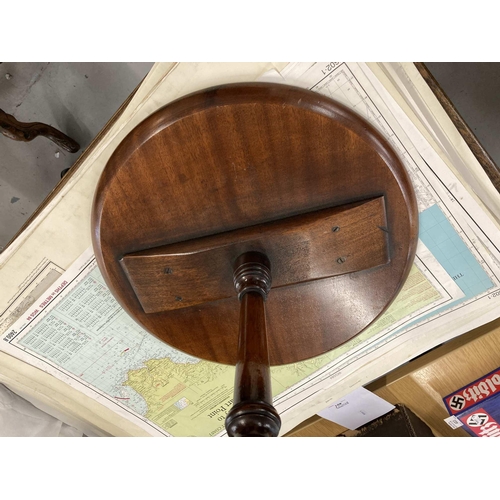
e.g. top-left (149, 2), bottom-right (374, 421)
top-left (121, 196), bottom-right (389, 313)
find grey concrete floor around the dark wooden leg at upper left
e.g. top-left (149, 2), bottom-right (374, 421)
top-left (0, 62), bottom-right (152, 251)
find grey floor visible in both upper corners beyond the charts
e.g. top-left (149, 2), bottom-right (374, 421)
top-left (0, 62), bottom-right (500, 251)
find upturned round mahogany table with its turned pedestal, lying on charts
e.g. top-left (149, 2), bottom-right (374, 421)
top-left (92, 84), bottom-right (418, 436)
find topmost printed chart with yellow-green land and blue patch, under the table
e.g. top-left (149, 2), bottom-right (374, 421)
top-left (1, 63), bottom-right (500, 436)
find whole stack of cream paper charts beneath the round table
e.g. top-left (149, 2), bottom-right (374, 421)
top-left (0, 63), bottom-right (500, 436)
